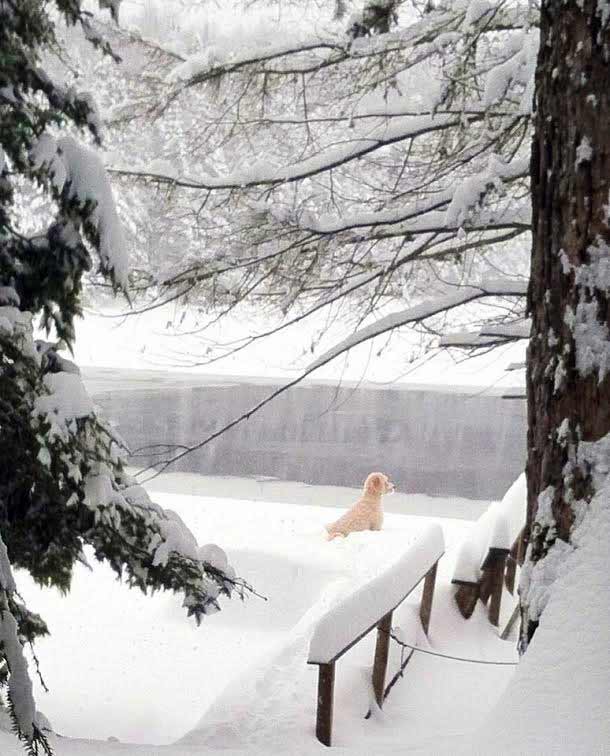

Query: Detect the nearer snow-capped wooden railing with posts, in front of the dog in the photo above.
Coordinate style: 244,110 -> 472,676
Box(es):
307,524 -> 445,746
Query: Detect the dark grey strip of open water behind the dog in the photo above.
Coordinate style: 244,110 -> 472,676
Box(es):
88,370 -> 526,499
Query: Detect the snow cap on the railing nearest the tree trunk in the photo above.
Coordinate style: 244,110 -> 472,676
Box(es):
453,473 -> 527,583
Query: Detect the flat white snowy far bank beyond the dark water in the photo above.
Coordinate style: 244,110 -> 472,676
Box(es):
65,296 -> 525,388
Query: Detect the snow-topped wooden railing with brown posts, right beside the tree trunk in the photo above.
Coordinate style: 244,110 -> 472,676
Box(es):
451,474 -> 527,625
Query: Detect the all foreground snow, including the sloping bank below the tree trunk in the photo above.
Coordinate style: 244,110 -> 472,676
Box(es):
0,476 -> 610,756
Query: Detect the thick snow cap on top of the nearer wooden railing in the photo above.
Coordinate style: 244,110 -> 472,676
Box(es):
308,523 -> 445,664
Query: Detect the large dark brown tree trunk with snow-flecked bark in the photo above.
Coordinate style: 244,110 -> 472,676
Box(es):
521,0 -> 610,650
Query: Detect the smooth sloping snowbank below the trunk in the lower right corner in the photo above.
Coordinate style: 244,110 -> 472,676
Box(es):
477,487 -> 610,756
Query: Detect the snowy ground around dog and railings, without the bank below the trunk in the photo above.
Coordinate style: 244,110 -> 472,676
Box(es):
0,476 -> 515,756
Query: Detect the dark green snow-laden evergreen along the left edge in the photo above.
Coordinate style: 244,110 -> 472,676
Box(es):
0,0 -> 247,753
